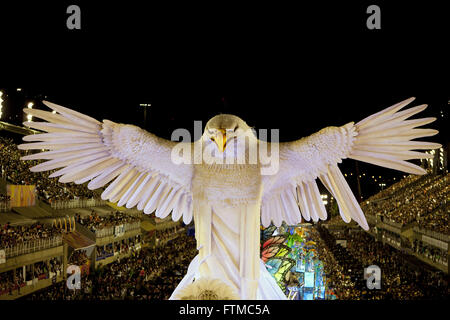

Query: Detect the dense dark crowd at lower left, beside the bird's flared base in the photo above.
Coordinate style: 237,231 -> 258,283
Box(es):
26,235 -> 197,300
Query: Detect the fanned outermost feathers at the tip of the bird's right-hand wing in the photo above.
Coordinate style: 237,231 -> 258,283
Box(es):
349,98 -> 441,175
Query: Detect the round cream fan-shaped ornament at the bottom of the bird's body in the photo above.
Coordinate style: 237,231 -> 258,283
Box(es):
174,277 -> 240,300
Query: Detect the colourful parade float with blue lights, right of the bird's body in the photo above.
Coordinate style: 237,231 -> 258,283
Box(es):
261,223 -> 336,300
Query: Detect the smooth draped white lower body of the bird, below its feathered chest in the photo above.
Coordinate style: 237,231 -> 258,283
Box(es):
171,204 -> 286,300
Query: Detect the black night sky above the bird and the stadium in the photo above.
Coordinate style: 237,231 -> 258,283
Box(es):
0,1 -> 450,196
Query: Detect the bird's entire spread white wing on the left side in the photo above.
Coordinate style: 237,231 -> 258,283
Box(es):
19,101 -> 193,223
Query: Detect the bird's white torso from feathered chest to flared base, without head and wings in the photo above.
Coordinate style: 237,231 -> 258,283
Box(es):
172,148 -> 286,300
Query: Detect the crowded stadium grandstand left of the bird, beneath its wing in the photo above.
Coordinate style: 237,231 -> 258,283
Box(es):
0,126 -> 190,300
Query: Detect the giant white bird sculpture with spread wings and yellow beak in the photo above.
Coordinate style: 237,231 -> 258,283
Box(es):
19,98 -> 440,299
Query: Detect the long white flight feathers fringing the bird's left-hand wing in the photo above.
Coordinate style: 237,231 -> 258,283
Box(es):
18,101 -> 192,224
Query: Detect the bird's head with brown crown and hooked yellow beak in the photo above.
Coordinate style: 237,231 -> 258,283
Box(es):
203,114 -> 251,153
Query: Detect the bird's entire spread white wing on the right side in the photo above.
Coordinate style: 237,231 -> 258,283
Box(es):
261,98 -> 441,230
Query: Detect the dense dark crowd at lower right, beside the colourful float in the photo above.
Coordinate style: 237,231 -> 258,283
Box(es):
318,226 -> 448,300
